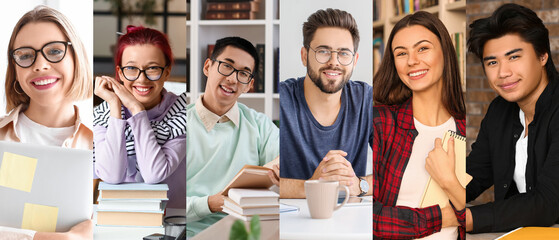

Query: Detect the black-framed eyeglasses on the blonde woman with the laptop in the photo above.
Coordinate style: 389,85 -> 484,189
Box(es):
10,41 -> 72,68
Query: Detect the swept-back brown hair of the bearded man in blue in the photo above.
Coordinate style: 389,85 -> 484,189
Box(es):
303,8 -> 359,53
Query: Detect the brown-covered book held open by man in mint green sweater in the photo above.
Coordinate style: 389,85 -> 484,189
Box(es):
222,165 -> 274,196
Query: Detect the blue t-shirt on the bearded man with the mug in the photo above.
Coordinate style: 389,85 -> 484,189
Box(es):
280,78 -> 373,179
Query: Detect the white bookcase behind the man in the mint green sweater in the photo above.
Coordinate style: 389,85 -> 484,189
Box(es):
186,0 -> 279,120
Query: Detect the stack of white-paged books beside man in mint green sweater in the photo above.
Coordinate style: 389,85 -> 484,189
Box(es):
223,188 -> 279,221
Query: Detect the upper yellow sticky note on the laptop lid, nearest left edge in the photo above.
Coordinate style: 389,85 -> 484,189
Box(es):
0,152 -> 37,192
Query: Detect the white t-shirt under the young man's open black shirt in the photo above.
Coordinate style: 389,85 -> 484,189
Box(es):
513,109 -> 528,193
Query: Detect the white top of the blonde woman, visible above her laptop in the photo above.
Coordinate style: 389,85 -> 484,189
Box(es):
15,112 -> 75,146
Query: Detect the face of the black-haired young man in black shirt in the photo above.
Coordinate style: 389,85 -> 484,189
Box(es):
483,34 -> 548,105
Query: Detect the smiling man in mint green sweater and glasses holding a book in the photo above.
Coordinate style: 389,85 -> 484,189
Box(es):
186,37 -> 279,236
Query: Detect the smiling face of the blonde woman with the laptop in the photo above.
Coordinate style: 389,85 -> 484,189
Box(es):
13,22 -> 74,106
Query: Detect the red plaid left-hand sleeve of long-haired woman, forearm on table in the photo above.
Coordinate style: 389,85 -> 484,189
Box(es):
373,107 -> 442,239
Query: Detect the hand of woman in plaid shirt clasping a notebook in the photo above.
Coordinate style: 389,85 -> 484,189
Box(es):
425,138 -> 459,189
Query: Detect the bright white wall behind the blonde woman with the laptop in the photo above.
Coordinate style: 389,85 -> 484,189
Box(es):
0,0 -> 93,127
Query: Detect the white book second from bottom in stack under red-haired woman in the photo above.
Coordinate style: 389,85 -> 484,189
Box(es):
97,199 -> 165,211
